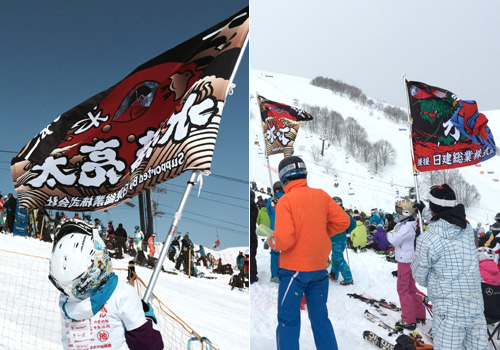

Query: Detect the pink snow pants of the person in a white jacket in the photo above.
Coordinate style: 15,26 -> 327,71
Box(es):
397,262 -> 426,323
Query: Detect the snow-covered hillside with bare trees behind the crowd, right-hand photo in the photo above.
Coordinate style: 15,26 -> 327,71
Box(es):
249,70 -> 500,225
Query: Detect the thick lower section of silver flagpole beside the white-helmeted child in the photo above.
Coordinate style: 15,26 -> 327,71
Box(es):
143,170 -> 200,303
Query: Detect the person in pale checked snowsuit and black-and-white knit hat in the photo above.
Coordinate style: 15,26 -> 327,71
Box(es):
411,184 -> 488,350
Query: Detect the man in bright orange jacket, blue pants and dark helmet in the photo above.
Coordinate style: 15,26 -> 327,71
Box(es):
269,156 -> 350,350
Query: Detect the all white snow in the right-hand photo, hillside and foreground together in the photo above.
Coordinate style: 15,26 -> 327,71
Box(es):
249,70 -> 500,350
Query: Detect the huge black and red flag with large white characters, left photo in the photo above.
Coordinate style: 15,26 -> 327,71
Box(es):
11,7 -> 249,212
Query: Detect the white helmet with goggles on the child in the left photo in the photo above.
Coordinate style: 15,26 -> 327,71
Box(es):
49,219 -> 112,299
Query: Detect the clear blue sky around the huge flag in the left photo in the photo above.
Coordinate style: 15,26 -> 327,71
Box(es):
0,0 -> 249,249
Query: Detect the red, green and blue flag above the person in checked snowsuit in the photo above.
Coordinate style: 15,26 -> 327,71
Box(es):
406,81 -> 496,172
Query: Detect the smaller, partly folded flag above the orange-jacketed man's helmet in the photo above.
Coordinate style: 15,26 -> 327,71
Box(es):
258,96 -> 313,157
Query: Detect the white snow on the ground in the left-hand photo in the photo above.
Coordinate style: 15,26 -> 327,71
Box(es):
0,234 -> 250,350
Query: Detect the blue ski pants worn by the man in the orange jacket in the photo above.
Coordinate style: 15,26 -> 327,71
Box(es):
276,269 -> 338,350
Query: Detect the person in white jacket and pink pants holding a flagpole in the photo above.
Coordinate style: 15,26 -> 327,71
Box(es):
387,210 -> 425,330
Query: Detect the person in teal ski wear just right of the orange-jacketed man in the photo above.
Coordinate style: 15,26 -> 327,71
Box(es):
330,197 -> 356,286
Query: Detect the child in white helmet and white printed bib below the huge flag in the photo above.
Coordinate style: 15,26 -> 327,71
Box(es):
49,219 -> 163,350
